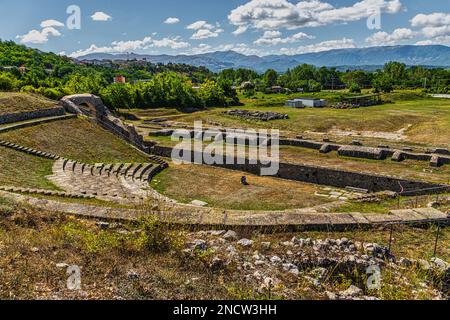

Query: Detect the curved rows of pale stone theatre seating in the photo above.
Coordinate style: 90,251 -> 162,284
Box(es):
48,159 -> 163,204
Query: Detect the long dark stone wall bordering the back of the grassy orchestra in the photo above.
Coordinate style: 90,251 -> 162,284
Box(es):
150,146 -> 450,195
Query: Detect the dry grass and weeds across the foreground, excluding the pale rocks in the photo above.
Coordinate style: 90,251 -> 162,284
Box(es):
0,199 -> 450,299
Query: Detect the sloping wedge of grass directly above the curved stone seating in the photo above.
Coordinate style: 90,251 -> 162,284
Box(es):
0,118 -> 148,163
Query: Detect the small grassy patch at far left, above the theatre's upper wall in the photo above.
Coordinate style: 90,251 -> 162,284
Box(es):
0,92 -> 58,115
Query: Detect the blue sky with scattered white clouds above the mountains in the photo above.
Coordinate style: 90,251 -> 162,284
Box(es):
0,0 -> 450,56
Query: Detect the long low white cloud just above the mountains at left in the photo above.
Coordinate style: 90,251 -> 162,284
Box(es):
69,37 -> 190,58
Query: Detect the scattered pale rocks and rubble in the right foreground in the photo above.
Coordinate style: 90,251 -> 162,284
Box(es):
183,231 -> 450,300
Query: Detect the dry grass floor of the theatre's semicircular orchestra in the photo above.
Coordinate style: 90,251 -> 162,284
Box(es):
152,161 -> 330,210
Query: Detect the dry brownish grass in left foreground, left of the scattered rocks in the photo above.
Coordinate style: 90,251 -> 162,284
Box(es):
0,205 -> 227,300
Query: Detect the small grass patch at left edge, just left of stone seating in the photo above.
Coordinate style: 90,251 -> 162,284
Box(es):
0,147 -> 58,190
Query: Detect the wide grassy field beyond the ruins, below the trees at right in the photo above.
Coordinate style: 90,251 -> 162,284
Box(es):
128,91 -> 450,147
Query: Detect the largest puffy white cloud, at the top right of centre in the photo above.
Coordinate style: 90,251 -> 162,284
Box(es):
228,0 -> 402,32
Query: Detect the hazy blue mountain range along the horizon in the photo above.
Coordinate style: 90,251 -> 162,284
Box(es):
78,45 -> 450,72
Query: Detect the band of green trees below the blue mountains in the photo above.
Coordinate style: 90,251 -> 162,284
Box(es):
0,41 -> 450,109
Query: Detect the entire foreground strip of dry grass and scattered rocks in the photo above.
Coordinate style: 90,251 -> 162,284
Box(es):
0,199 -> 450,300
